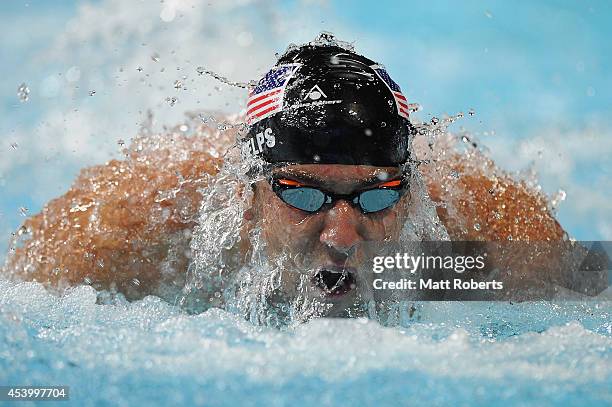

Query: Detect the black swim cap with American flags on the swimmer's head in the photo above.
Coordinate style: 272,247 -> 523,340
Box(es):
244,44 -> 413,167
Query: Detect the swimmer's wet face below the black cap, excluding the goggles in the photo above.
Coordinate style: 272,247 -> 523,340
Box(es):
250,164 -> 410,315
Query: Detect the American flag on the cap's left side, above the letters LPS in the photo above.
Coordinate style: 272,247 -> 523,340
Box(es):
247,64 -> 300,125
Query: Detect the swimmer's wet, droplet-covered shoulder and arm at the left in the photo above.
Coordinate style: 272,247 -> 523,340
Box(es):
3,152 -> 218,298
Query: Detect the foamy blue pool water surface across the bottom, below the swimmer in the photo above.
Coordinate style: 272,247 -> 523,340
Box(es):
0,280 -> 612,406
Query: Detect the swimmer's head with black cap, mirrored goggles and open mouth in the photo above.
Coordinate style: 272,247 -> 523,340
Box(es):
230,46 -> 415,315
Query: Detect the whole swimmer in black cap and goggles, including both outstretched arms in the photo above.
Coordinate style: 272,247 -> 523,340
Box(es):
4,39 -> 596,315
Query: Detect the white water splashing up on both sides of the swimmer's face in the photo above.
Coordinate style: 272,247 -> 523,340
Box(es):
175,107 -> 449,327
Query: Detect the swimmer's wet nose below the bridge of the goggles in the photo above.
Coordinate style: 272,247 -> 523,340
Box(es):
319,201 -> 363,254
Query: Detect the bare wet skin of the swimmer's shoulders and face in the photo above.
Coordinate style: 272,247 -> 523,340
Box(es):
0,129 -> 572,302
